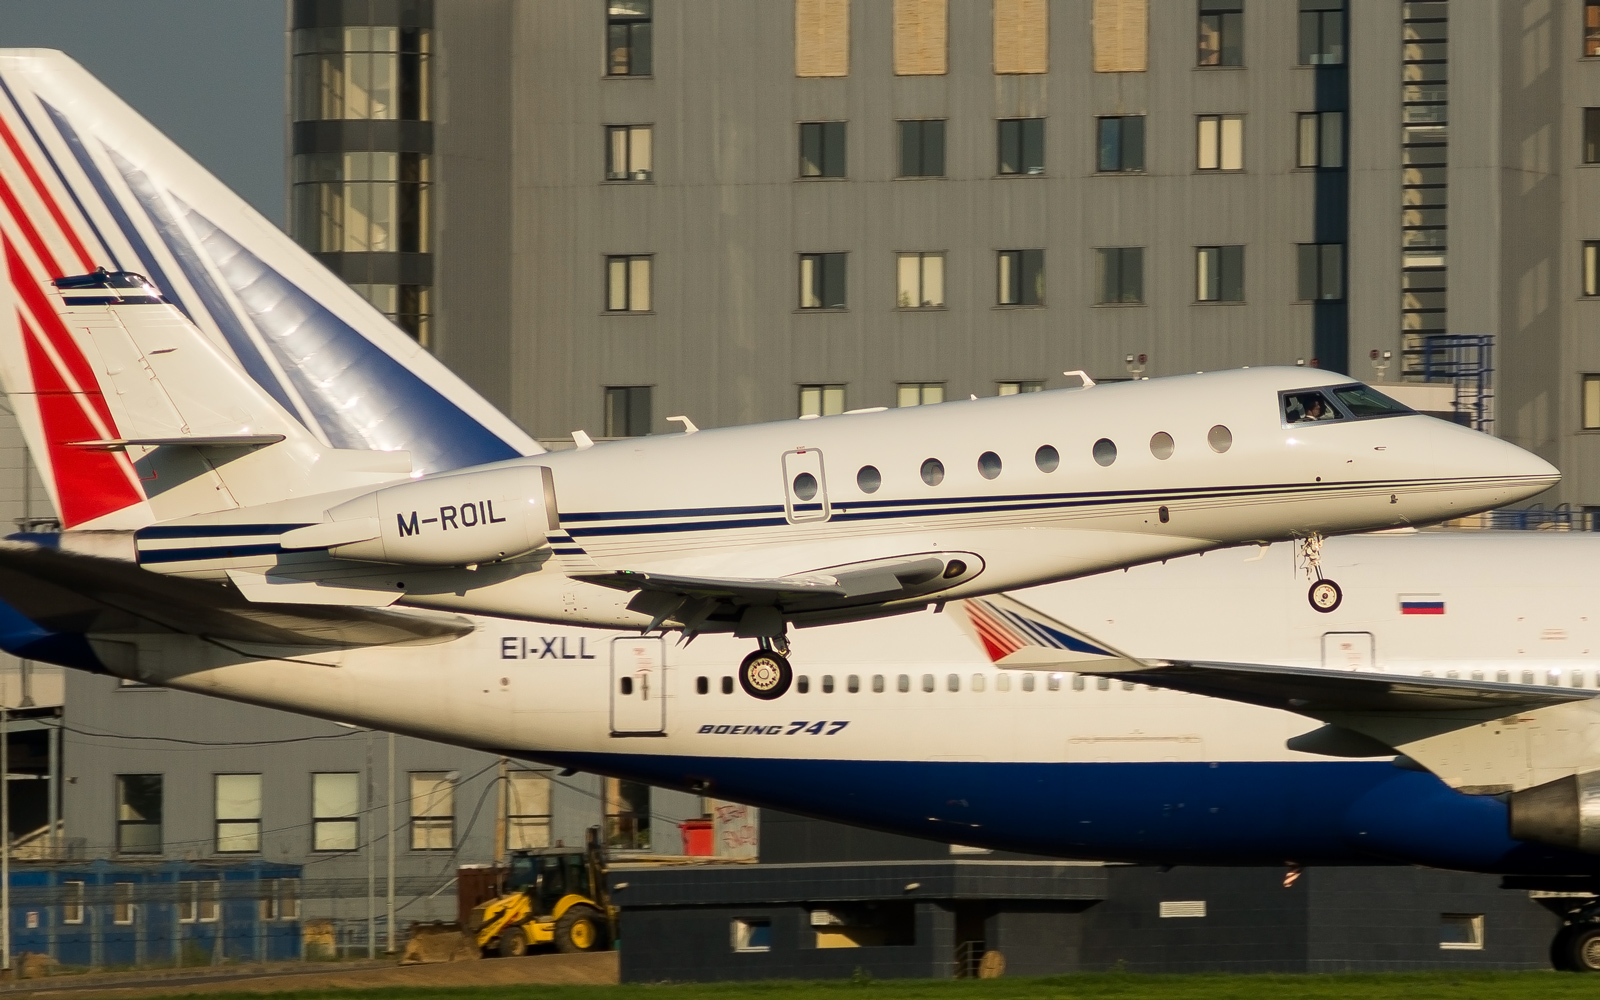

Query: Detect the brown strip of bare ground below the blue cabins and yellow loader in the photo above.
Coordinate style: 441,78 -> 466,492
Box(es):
0,952 -> 618,1000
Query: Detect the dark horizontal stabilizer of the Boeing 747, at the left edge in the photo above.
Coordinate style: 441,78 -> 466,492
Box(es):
0,541 -> 474,648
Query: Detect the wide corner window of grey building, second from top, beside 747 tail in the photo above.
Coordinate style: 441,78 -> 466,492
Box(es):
291,152 -> 434,253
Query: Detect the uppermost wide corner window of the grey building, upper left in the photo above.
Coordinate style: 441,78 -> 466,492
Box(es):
291,26 -> 432,122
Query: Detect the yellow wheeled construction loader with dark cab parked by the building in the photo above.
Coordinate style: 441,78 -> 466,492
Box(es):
466,829 -> 616,958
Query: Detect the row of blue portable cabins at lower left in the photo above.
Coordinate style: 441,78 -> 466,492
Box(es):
11,859 -> 301,968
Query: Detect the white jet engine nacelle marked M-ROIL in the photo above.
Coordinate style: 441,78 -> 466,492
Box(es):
328,466 -> 558,566
